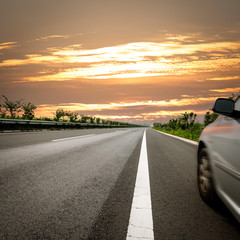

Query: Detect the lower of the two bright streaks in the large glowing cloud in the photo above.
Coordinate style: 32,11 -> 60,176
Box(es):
20,57 -> 240,82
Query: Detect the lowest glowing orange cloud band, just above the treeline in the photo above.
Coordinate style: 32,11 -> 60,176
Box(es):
33,97 -> 219,119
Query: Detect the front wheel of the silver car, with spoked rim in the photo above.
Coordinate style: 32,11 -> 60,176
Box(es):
197,148 -> 216,204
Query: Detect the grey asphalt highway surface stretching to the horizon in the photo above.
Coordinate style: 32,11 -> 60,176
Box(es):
0,128 -> 240,240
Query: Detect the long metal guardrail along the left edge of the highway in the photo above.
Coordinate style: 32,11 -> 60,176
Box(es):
0,118 -> 137,128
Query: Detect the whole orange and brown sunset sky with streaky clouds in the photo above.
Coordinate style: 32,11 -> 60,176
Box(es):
0,0 -> 240,123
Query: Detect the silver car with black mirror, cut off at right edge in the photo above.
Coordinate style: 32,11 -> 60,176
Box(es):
197,94 -> 240,222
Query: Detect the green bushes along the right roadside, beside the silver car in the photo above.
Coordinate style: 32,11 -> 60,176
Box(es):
153,111 -> 218,141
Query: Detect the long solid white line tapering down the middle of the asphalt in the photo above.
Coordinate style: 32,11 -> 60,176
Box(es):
126,130 -> 154,240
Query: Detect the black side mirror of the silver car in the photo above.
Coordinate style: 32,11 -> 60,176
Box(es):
212,98 -> 235,117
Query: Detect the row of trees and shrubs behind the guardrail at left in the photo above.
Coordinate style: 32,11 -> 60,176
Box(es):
0,95 -> 133,126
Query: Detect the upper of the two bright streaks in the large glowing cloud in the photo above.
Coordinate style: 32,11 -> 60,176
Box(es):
50,40 -> 240,58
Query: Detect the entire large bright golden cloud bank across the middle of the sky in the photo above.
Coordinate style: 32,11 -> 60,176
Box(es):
0,35 -> 240,82
